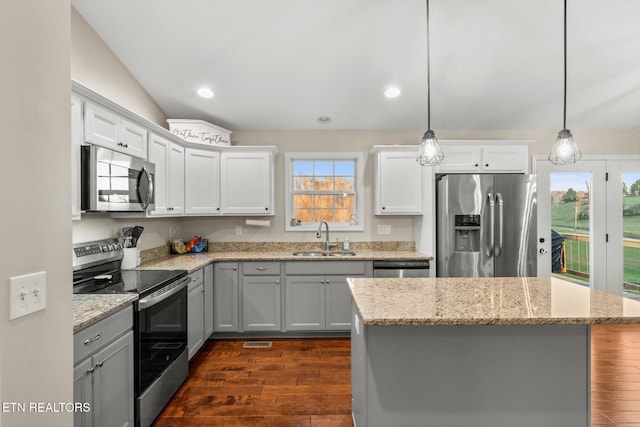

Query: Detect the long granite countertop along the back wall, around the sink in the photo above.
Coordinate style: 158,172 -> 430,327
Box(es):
137,250 -> 433,273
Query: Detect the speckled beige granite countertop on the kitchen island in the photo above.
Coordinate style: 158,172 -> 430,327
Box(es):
348,277 -> 640,326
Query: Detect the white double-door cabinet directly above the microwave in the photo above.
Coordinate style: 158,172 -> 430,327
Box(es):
84,102 -> 147,159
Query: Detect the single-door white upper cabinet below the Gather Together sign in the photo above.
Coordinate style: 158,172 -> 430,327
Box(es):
184,148 -> 221,215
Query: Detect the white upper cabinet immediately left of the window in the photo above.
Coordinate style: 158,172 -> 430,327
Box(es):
220,151 -> 273,215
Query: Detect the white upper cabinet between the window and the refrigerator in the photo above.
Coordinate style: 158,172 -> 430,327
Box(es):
371,146 -> 425,215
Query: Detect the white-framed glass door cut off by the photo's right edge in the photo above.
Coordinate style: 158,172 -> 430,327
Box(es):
607,160 -> 640,299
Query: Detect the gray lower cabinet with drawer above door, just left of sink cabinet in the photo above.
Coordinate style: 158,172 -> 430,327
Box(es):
242,262 -> 282,331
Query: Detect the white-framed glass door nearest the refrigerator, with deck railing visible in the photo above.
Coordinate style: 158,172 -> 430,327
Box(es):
535,159 -> 607,290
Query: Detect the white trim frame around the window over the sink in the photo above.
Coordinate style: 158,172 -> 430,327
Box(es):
284,152 -> 364,231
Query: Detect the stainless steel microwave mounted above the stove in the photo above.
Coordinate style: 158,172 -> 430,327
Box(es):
81,145 -> 156,212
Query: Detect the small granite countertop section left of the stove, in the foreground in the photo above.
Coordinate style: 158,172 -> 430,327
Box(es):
73,294 -> 138,332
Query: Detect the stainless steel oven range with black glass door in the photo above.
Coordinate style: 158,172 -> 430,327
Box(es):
73,239 -> 191,427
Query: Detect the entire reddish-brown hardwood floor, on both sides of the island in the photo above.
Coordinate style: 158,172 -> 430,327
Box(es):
154,325 -> 640,427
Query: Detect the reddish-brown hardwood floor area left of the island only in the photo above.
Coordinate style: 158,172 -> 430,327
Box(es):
154,339 -> 353,427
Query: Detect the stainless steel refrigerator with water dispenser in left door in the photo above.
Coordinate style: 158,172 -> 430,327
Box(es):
436,174 -> 537,277
